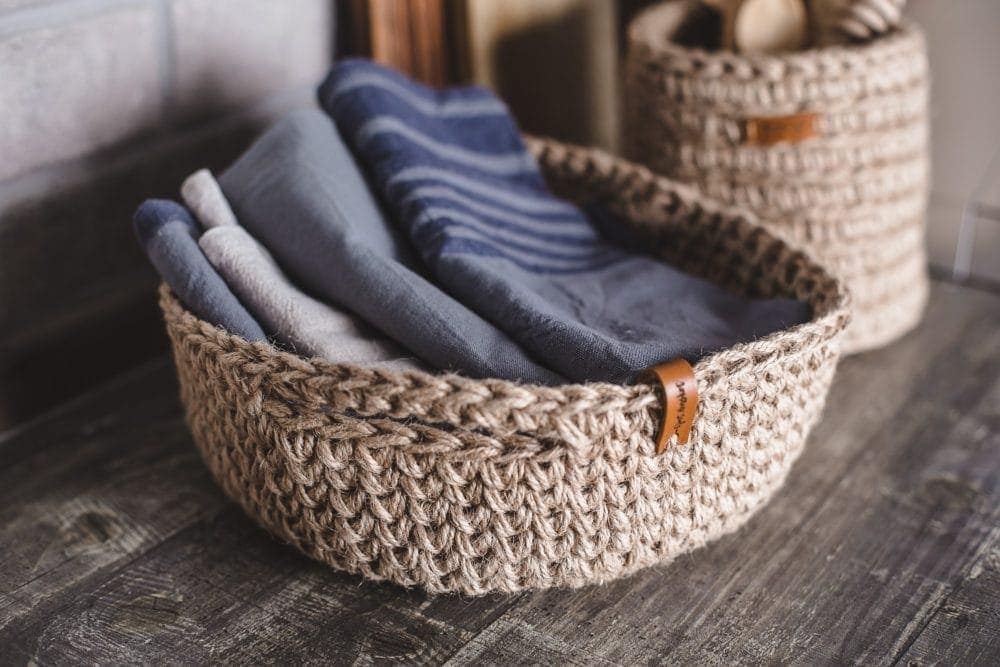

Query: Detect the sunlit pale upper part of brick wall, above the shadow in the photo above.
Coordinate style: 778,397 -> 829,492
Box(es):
0,0 -> 333,181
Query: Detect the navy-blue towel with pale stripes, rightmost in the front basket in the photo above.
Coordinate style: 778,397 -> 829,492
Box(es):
319,60 -> 809,382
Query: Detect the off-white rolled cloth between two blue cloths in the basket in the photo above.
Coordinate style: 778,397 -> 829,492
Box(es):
181,169 -> 421,370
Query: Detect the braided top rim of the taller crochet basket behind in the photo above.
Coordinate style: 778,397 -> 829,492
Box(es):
627,0 -> 923,71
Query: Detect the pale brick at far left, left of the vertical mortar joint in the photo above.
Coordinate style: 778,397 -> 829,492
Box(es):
0,5 -> 162,179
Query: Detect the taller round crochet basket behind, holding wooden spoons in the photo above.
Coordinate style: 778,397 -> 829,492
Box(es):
624,0 -> 929,352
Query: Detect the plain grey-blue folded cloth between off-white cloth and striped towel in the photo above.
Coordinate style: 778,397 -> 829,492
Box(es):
219,110 -> 563,384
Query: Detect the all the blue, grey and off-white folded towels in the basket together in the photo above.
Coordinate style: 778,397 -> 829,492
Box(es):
135,60 -> 810,385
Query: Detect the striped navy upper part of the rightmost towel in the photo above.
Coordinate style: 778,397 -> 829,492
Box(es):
323,61 -> 626,273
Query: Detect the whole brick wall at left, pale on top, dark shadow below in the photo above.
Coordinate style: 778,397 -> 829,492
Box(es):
0,0 -> 335,428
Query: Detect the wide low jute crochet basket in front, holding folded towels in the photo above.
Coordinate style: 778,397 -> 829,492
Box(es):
160,140 -> 849,595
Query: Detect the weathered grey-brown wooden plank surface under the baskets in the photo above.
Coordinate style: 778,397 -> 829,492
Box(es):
0,283 -> 1000,665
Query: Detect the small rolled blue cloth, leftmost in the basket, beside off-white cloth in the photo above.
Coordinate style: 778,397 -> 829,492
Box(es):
132,199 -> 266,341
